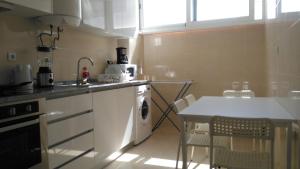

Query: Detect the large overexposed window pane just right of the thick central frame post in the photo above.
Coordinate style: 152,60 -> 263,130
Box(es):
197,0 -> 249,21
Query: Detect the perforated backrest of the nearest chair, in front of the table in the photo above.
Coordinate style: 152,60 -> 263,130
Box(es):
210,116 -> 274,140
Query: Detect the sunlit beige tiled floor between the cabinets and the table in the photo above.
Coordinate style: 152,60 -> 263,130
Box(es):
105,125 -> 209,169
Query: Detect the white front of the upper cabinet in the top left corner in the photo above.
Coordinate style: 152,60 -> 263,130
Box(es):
0,0 -> 52,13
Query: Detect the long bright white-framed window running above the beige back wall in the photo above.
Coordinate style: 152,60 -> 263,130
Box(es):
140,0 -> 278,33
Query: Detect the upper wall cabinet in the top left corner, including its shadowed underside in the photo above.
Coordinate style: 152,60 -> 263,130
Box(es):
0,0 -> 52,17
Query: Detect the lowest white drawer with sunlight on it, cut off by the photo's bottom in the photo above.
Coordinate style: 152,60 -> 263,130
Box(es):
61,151 -> 94,169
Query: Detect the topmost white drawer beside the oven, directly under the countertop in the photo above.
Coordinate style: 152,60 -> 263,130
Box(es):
45,94 -> 92,121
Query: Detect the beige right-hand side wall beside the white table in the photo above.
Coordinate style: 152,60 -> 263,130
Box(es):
266,13 -> 300,168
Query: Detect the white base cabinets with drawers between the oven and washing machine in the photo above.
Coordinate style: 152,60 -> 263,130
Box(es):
40,87 -> 136,169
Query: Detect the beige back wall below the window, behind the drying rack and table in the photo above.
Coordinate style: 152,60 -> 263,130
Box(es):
144,25 -> 267,125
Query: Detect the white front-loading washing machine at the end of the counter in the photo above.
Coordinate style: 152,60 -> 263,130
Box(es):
134,85 -> 152,145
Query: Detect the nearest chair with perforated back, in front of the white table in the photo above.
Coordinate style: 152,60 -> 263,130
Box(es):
209,116 -> 274,169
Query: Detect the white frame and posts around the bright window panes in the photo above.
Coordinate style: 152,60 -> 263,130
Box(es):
139,0 -> 300,34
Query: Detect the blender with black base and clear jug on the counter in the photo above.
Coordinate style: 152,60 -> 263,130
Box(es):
37,46 -> 54,88
